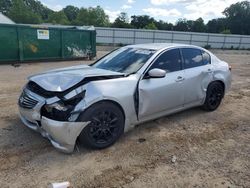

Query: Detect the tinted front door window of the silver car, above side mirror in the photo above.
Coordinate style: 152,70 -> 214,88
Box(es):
150,49 -> 181,72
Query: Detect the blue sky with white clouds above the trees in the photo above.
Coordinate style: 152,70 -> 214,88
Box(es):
40,0 -> 244,23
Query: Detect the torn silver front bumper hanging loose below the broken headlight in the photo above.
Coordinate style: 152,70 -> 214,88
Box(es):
19,91 -> 89,153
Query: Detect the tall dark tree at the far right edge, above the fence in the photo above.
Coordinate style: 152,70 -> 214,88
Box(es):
223,1 -> 250,35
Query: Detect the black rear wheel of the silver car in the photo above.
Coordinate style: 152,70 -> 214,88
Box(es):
202,82 -> 224,111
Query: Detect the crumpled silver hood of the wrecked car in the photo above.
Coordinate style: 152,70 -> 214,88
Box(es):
29,65 -> 123,92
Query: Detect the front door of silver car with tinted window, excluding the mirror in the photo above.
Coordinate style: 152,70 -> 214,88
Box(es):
138,49 -> 184,120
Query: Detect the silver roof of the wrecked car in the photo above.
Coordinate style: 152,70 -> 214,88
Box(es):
126,43 -> 200,51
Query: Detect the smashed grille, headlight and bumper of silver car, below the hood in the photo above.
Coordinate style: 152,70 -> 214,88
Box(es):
19,81 -> 88,153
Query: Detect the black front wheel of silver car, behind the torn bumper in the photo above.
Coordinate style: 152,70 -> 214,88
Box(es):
78,101 -> 125,149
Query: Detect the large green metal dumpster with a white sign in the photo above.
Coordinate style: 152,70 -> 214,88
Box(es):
0,24 -> 96,62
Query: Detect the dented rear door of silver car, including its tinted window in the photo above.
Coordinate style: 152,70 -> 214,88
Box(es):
181,48 -> 213,105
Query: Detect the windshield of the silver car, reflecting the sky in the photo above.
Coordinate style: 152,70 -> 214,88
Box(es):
92,47 -> 155,74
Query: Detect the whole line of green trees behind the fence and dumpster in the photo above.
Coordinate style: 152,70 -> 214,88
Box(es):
0,0 -> 250,35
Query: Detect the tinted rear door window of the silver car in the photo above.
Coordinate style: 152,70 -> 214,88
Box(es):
182,48 -> 204,69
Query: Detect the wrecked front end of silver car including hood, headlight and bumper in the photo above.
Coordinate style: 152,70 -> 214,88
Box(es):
19,65 -> 127,153
